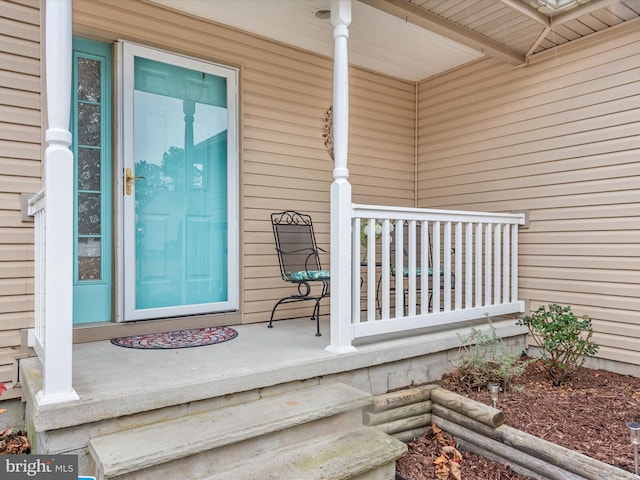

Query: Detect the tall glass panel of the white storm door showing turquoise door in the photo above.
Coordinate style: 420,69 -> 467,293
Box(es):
131,56 -> 228,313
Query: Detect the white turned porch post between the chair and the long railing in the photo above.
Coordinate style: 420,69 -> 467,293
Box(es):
326,0 -> 355,353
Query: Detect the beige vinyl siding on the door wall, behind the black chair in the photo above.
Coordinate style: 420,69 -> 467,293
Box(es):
73,0 -> 415,322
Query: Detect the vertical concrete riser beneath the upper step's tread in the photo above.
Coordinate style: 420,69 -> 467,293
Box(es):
106,409 -> 360,480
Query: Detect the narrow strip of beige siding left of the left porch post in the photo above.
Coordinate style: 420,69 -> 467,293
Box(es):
0,0 -> 42,400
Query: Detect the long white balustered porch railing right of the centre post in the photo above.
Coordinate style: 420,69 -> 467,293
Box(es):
351,204 -> 524,339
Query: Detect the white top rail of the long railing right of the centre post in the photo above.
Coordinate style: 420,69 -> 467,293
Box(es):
351,203 -> 525,225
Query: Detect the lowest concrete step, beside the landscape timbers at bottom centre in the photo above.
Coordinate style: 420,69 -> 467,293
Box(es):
198,427 -> 407,480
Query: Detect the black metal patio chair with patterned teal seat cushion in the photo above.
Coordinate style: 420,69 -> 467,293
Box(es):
268,210 -> 331,336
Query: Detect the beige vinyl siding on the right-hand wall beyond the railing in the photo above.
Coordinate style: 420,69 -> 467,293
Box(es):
418,21 -> 640,364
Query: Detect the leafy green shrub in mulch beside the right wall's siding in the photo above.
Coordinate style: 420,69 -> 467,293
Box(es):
518,304 -> 599,386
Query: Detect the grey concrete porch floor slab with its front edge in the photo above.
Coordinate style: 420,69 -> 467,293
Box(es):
20,317 -> 526,431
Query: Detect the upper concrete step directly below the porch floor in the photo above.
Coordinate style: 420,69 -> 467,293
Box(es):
89,383 -> 372,480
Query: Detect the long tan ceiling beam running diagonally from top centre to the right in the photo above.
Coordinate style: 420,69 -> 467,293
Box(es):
360,0 -> 525,65
